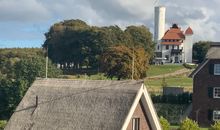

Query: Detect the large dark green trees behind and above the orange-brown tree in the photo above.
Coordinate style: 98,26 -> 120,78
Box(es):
43,20 -> 154,69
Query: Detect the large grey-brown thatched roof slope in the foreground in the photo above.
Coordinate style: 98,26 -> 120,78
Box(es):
5,79 -> 150,130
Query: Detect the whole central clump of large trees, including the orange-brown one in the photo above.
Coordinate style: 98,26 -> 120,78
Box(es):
43,20 -> 154,79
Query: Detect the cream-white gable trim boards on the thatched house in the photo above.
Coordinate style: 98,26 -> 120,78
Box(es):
121,84 -> 162,130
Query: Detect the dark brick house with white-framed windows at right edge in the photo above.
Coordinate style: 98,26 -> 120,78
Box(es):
190,43 -> 220,126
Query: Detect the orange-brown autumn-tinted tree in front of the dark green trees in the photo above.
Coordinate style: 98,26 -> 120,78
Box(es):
101,46 -> 148,80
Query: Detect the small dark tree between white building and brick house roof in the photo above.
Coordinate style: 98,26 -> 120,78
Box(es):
193,41 -> 211,63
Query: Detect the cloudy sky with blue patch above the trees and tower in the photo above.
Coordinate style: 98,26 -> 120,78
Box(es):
0,0 -> 220,48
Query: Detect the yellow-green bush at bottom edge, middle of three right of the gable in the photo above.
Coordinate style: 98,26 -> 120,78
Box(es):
179,118 -> 199,130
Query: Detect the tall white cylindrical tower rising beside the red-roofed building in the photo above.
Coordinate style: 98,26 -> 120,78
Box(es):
154,6 -> 166,52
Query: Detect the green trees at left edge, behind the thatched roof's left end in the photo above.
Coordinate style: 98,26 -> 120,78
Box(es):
0,48 -> 62,120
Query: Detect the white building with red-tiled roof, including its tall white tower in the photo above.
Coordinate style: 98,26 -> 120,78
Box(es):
154,6 -> 193,63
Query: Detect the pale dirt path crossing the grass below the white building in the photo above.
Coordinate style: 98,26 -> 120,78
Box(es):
147,68 -> 193,79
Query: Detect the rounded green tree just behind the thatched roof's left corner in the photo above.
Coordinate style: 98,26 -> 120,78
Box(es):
14,57 -> 61,93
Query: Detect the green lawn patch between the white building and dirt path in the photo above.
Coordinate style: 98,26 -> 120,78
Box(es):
147,64 -> 184,76
